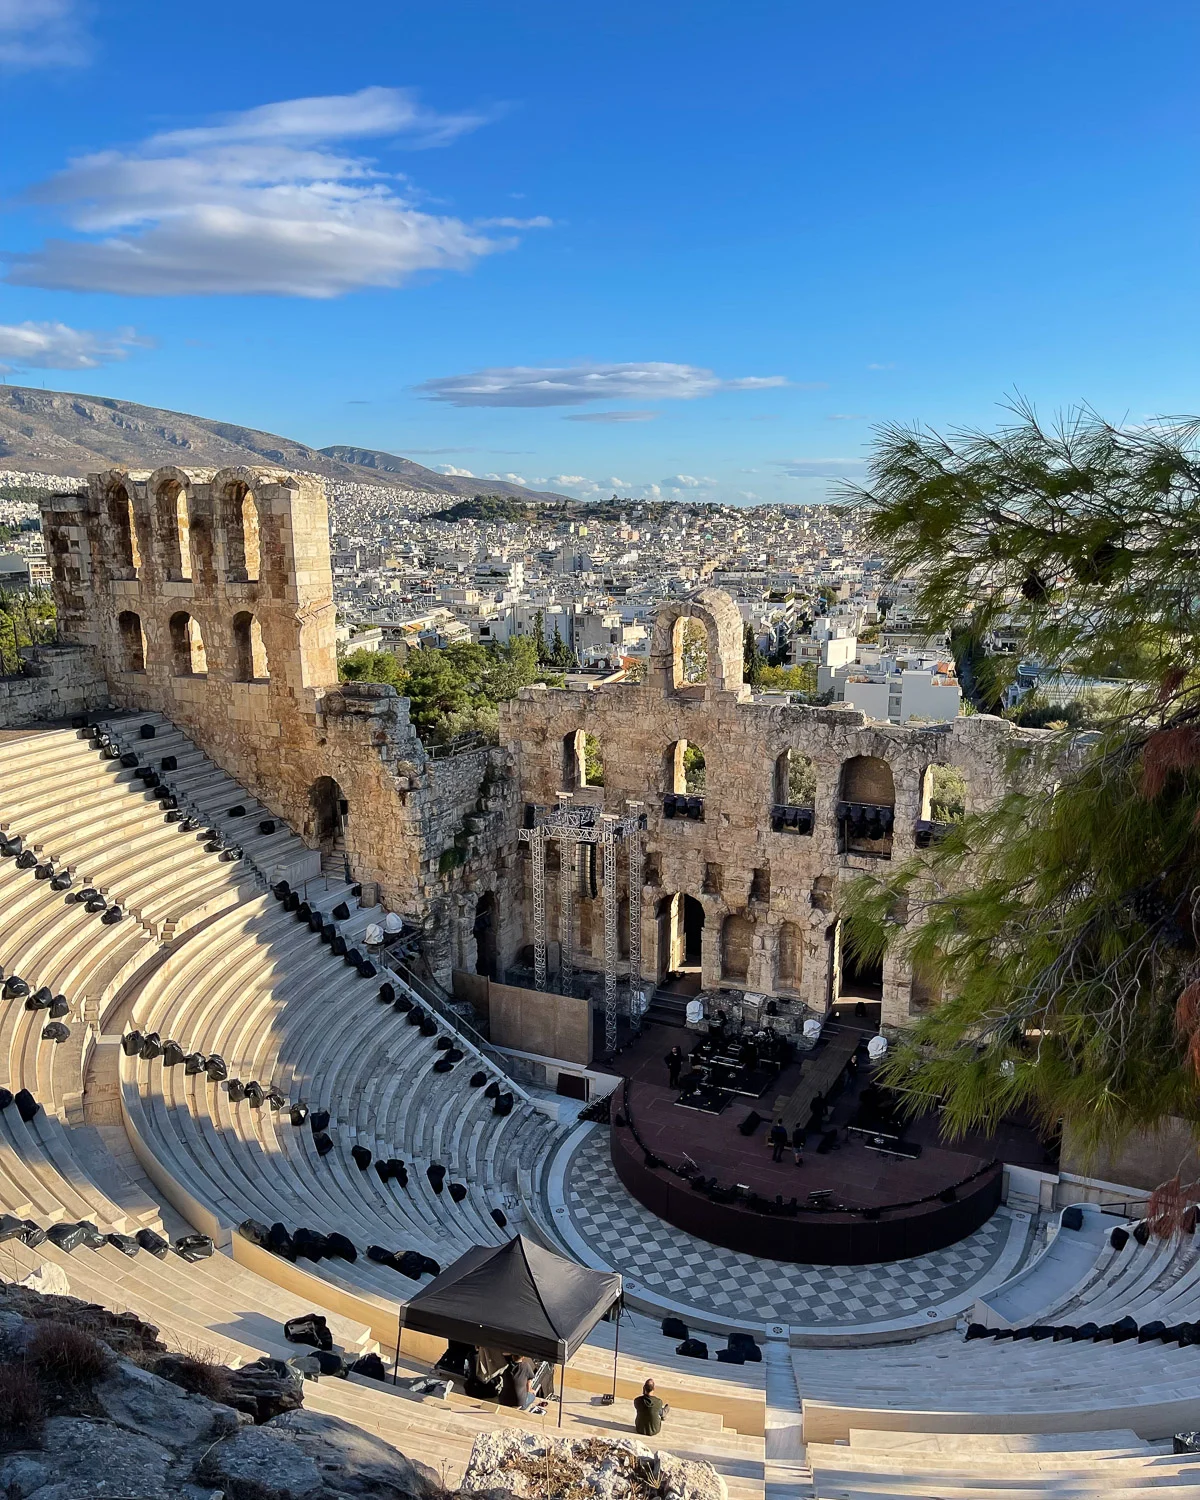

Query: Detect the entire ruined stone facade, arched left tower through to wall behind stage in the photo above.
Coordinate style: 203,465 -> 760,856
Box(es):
30,468 -> 1040,1025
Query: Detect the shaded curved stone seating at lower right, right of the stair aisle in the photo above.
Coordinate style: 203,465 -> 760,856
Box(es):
792,1206 -> 1200,1446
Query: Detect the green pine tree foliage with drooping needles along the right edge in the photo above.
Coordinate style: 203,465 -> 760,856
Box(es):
845,407 -> 1200,1146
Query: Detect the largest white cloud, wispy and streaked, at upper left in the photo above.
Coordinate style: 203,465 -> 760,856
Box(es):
9,85 -> 515,297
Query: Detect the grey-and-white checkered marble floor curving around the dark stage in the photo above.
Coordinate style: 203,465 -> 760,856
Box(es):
566,1130 -> 1008,1326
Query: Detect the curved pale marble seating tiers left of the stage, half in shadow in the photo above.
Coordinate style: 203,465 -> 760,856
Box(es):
0,716 -> 764,1500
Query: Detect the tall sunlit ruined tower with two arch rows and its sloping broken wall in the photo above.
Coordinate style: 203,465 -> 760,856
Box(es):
35,468 -> 512,978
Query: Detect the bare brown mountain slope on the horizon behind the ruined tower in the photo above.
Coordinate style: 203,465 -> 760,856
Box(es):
0,386 -> 573,501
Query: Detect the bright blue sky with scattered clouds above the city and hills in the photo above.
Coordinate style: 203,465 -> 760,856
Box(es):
0,0 -> 1200,501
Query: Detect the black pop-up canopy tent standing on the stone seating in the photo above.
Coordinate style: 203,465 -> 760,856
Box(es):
396,1235 -> 621,1425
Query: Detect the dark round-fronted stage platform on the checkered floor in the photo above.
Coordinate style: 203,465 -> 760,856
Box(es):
609,1026 -> 1041,1266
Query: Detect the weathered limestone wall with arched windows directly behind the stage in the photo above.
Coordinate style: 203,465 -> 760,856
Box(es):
501,591 -> 1041,1026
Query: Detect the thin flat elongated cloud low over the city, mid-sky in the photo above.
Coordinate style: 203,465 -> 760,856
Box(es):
417,362 -> 788,407
